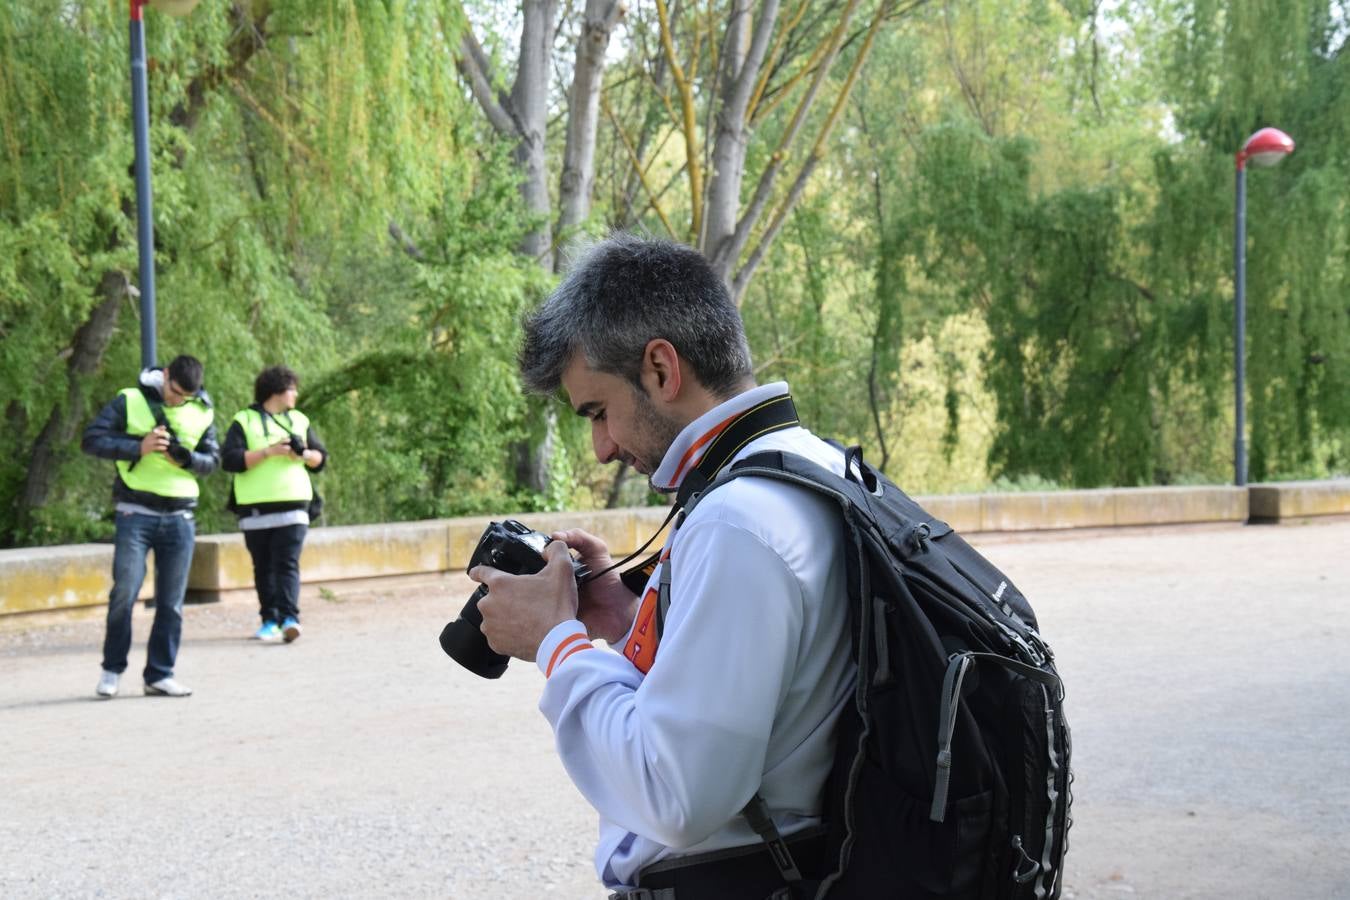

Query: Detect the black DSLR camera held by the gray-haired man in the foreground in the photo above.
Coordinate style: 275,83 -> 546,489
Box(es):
440,519 -> 590,679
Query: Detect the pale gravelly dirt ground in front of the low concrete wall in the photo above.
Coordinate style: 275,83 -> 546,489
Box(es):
0,519 -> 1350,900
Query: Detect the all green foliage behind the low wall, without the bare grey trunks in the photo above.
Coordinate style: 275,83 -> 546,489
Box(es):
0,0 -> 1350,545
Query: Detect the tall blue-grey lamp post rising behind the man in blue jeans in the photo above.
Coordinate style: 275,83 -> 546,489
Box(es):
131,0 -> 197,368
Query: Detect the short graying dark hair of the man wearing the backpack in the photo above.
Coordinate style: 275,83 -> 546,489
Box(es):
518,233 -> 753,398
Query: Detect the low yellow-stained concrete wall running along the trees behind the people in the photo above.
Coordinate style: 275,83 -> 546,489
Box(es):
0,479 -> 1350,615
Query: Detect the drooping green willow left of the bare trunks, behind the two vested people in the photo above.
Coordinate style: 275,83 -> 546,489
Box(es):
0,0 -> 535,542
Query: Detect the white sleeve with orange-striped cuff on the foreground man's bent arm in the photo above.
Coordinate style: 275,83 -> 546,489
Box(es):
539,519 -> 802,849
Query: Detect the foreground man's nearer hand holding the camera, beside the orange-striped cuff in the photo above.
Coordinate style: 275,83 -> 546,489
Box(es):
468,541 -> 576,663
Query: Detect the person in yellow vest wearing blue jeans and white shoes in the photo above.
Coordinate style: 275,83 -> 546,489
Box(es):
80,356 -> 220,699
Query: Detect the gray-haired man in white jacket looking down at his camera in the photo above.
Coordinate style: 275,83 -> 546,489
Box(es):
470,235 -> 856,900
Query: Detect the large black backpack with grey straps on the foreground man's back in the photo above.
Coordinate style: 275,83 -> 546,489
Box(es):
680,448 -> 1072,900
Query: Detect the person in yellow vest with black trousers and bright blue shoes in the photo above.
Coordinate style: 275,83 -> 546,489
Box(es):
221,366 -> 328,644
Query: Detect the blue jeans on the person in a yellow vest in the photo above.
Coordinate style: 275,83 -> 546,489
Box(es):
103,513 -> 196,684
